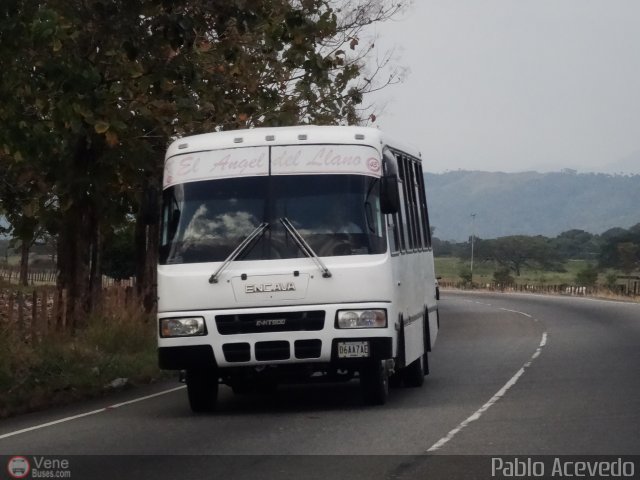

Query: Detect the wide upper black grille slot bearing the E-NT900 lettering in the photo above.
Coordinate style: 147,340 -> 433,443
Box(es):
216,310 -> 325,335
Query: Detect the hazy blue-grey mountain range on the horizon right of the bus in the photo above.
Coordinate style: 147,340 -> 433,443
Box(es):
425,170 -> 640,241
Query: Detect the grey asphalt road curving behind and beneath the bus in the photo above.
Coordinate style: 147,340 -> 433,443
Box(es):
0,292 -> 640,478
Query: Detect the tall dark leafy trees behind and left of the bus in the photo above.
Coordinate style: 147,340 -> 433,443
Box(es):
0,0 -> 401,325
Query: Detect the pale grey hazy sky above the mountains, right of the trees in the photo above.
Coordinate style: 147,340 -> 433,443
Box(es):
369,0 -> 640,173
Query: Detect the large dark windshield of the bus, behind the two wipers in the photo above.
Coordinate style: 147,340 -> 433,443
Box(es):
160,174 -> 387,265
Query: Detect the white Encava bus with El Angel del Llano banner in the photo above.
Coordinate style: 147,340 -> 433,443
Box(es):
158,126 -> 439,411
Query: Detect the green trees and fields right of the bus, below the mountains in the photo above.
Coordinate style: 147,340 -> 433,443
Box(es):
434,223 -> 640,286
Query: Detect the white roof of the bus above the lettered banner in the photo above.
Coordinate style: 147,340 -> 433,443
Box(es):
166,125 -> 420,158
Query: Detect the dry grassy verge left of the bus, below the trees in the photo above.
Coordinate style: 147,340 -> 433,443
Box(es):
0,314 -> 163,418
